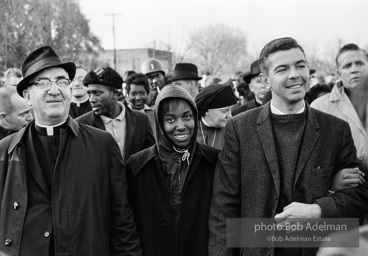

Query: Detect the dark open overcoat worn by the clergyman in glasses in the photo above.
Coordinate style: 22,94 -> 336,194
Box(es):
0,118 -> 141,256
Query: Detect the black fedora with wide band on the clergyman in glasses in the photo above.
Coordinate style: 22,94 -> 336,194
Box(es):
17,46 -> 76,97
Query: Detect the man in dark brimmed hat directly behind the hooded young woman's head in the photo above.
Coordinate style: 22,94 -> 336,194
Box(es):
171,63 -> 202,99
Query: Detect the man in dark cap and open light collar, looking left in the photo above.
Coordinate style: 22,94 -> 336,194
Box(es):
76,67 -> 155,162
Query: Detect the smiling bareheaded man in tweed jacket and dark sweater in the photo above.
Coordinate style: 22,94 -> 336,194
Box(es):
209,38 -> 368,256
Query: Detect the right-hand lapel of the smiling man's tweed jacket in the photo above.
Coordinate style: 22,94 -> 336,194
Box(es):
294,104 -> 319,188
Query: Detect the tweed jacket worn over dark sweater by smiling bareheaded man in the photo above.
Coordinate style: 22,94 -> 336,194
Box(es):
209,103 -> 368,256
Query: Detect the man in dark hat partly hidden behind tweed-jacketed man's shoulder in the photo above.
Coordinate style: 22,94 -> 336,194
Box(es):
232,60 -> 270,116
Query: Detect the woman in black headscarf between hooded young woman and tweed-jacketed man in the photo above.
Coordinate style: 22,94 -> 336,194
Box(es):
195,84 -> 236,149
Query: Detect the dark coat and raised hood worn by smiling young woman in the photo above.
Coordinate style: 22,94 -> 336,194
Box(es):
126,85 -> 219,256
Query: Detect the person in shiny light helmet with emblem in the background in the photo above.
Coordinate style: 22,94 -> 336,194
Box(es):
141,58 -> 166,107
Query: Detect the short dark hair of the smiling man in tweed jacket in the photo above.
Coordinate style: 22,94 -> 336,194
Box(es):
259,37 -> 305,74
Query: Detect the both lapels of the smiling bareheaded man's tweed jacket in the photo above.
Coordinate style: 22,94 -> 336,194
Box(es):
257,102 -> 320,194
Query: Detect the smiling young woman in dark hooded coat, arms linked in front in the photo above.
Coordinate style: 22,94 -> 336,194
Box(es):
126,85 -> 219,256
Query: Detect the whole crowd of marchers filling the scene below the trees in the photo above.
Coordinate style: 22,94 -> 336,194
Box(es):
0,37 -> 368,256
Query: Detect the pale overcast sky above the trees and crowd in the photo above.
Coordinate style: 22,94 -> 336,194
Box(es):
80,0 -> 368,59
